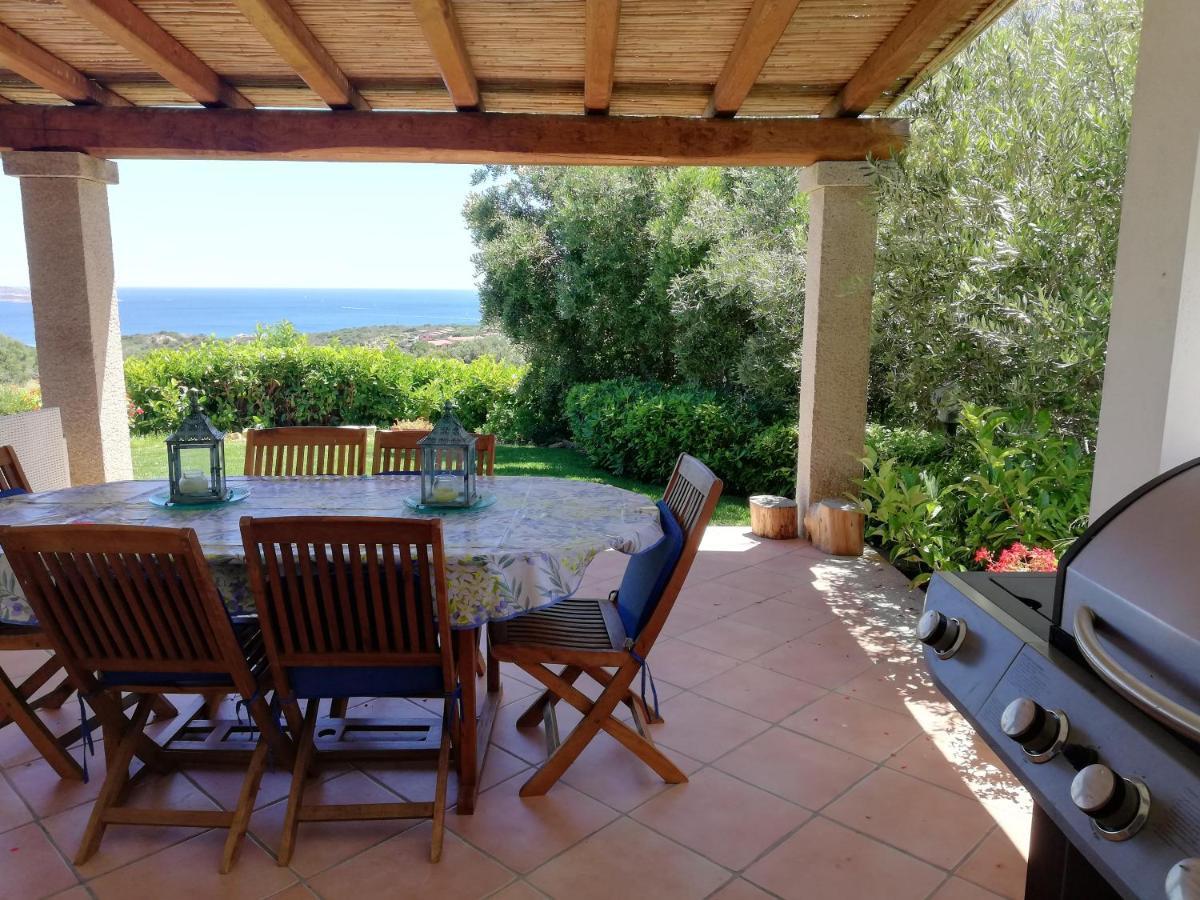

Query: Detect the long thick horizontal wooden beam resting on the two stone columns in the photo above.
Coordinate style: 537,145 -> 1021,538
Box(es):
0,104 -> 908,166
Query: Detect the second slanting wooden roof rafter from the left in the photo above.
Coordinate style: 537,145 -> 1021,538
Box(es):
60,0 -> 253,109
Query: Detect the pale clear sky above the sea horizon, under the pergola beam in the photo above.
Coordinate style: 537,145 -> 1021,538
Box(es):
0,160 -> 474,289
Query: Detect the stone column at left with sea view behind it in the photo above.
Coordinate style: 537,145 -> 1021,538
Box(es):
4,151 -> 133,485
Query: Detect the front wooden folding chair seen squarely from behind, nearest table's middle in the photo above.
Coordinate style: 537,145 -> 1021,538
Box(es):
241,516 -> 458,865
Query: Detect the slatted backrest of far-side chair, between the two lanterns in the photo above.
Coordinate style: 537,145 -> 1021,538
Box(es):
245,425 -> 367,476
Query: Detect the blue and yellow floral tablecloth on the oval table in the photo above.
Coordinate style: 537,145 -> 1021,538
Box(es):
0,475 -> 662,628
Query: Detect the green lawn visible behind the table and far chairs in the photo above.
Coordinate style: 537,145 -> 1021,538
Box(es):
131,434 -> 750,524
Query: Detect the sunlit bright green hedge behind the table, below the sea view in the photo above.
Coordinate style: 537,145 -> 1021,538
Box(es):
125,341 -> 523,434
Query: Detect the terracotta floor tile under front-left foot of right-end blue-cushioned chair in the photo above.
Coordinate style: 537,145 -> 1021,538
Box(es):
446,778 -> 618,872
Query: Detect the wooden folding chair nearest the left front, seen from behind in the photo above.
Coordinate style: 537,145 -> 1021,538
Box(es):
0,524 -> 293,872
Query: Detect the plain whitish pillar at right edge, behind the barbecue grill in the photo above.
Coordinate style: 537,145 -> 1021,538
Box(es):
1091,0 -> 1200,518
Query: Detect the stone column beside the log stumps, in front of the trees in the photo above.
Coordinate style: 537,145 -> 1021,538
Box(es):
796,162 -> 876,528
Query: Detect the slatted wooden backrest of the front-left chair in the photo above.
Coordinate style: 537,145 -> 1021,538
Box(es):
0,524 -> 254,692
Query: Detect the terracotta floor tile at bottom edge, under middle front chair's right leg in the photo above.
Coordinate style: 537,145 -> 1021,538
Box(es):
308,822 -> 512,900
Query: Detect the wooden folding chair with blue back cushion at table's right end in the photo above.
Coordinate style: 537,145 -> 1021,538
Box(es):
488,454 -> 722,797
